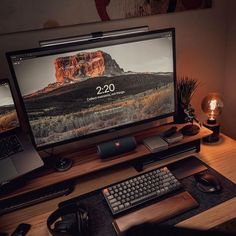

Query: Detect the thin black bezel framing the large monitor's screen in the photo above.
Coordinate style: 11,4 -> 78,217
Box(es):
6,28 -> 177,150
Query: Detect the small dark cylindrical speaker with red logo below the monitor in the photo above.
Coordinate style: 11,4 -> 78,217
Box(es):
97,136 -> 137,158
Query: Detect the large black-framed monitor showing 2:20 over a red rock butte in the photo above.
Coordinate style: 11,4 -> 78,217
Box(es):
7,29 -> 175,148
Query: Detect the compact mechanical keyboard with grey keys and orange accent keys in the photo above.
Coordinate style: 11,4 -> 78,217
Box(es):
102,167 -> 181,216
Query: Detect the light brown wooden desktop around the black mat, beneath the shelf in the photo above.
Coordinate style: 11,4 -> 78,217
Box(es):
0,135 -> 236,236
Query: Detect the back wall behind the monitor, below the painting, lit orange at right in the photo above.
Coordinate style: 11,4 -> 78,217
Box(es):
0,0 -> 227,136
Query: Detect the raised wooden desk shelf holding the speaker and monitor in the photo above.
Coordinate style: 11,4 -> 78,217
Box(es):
0,125 -> 211,200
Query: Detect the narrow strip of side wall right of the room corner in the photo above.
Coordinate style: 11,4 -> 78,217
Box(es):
222,0 -> 236,139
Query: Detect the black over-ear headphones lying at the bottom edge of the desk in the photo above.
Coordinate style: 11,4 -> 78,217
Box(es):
47,204 -> 89,236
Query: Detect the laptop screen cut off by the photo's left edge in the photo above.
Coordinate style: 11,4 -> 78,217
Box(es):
0,80 -> 20,134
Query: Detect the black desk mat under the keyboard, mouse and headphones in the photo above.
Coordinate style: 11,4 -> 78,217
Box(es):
59,156 -> 236,236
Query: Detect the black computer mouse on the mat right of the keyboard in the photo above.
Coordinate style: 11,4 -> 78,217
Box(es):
194,173 -> 222,193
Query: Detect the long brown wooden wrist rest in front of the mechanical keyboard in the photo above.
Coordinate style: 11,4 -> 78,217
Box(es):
113,191 -> 198,234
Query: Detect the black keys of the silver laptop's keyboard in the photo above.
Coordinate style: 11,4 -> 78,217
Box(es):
0,135 -> 23,160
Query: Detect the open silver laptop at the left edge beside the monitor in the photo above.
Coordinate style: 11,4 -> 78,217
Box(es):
0,79 -> 44,187
